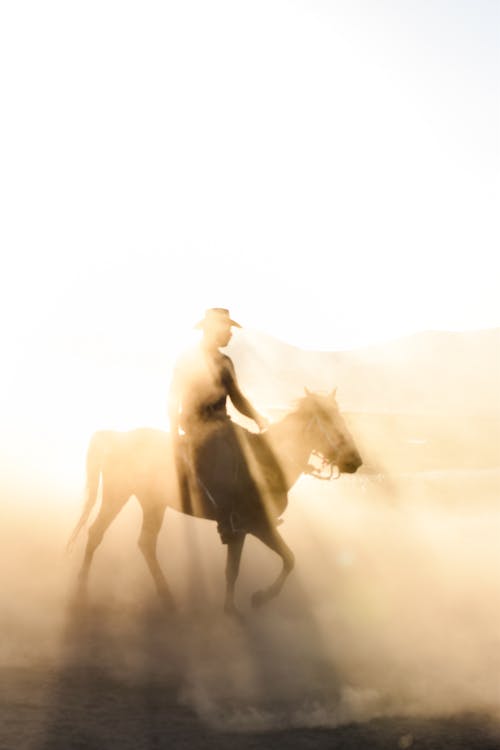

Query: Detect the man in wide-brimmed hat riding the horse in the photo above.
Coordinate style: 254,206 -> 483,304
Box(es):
169,307 -> 267,543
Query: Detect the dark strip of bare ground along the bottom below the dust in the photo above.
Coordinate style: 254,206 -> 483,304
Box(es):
0,666 -> 500,750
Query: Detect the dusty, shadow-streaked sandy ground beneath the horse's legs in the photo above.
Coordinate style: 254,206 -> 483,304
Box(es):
0,470 -> 500,750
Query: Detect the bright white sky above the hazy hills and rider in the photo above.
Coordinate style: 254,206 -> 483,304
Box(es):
0,0 -> 500,456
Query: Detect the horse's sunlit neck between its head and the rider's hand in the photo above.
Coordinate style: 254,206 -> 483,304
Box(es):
266,412 -> 311,487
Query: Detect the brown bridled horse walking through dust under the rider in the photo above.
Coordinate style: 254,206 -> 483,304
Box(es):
68,389 -> 362,615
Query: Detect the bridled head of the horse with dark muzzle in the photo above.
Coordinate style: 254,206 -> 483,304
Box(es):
300,388 -> 362,474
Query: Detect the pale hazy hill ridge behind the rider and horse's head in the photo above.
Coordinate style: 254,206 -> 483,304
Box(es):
228,328 -> 500,417
